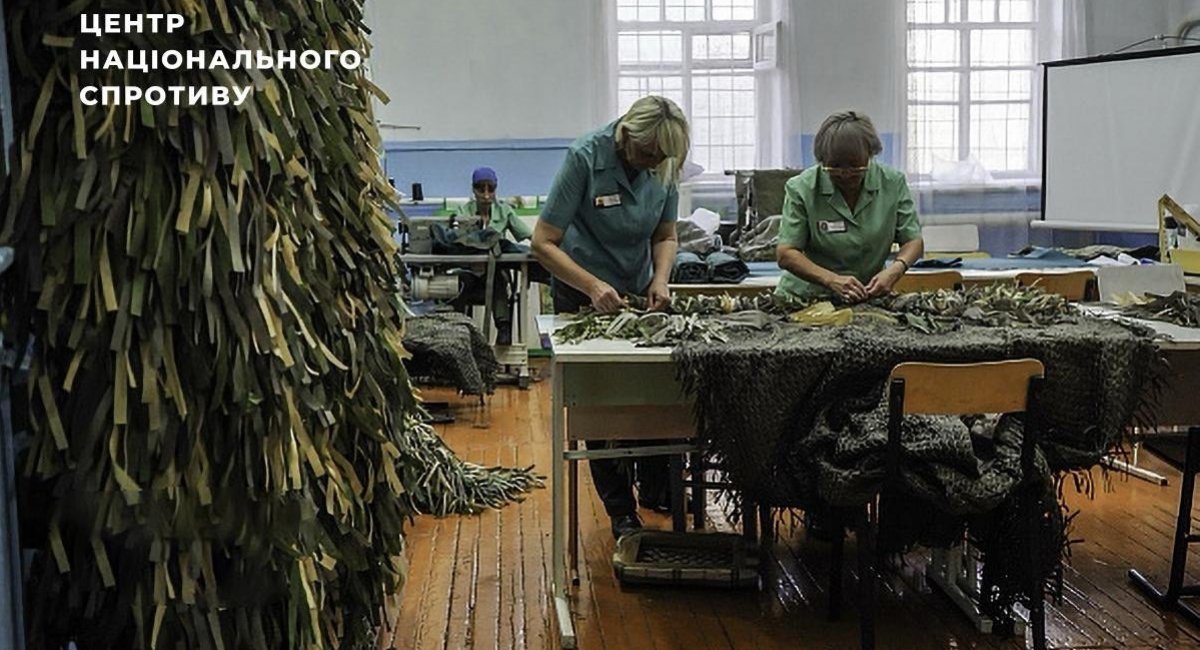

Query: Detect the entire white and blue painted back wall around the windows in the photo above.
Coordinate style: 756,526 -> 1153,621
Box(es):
367,0 -> 1200,252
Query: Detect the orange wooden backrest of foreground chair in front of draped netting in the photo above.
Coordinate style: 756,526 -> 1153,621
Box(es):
889,359 -> 1045,415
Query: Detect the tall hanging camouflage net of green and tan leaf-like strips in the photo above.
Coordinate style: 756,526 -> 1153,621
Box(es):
0,0 -> 539,650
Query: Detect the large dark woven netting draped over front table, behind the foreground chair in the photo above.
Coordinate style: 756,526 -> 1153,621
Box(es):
673,319 -> 1159,619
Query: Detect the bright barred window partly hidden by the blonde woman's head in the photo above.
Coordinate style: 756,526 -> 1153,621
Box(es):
614,0 -> 756,174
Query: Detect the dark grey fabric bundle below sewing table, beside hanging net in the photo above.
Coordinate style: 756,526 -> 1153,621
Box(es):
404,312 -> 499,395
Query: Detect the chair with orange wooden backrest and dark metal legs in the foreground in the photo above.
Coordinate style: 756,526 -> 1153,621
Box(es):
854,359 -> 1048,649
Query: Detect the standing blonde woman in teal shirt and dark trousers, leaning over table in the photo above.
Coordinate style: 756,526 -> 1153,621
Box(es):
533,96 -> 690,537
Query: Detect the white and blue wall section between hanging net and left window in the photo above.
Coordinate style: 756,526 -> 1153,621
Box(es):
367,0 -> 602,197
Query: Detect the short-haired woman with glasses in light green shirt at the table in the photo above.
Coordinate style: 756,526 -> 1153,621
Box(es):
775,110 -> 924,303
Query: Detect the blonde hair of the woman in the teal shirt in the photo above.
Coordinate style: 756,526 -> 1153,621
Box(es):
617,95 -> 691,185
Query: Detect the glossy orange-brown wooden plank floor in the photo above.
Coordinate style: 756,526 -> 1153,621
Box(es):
382,369 -> 1200,650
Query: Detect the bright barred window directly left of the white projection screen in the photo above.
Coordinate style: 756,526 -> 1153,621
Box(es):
906,0 -> 1037,177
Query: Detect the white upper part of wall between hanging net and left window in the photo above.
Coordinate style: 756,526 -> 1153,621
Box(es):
367,0 -> 602,140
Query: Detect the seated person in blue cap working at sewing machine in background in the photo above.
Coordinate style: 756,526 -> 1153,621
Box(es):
454,167 -> 533,345
